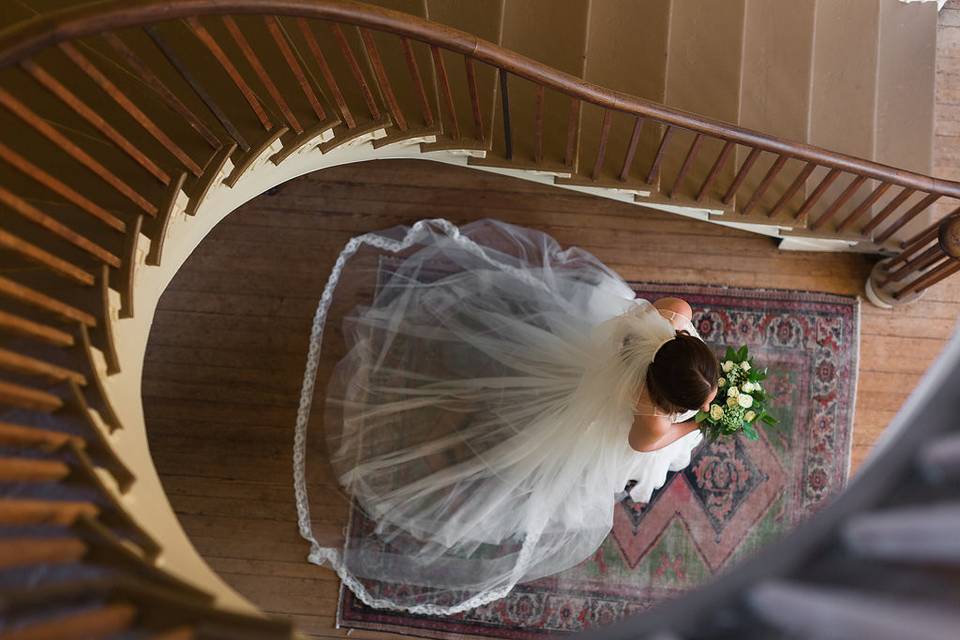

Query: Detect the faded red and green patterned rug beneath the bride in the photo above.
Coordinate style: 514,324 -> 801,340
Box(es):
338,284 -> 859,639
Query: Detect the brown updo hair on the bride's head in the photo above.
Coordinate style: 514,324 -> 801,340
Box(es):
646,331 -> 720,413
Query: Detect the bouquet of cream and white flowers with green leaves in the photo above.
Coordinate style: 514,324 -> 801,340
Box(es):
695,346 -> 779,442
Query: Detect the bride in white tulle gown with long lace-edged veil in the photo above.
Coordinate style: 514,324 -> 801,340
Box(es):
294,220 -> 719,615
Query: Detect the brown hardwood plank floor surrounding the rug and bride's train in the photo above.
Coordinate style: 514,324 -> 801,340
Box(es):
143,3 -> 960,637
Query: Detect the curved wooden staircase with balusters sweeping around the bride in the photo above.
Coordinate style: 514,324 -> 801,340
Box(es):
0,0 -> 960,640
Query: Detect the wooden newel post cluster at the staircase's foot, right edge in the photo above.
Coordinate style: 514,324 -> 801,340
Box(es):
866,215 -> 960,309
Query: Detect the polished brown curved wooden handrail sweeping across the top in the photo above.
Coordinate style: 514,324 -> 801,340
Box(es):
0,0 -> 960,198
